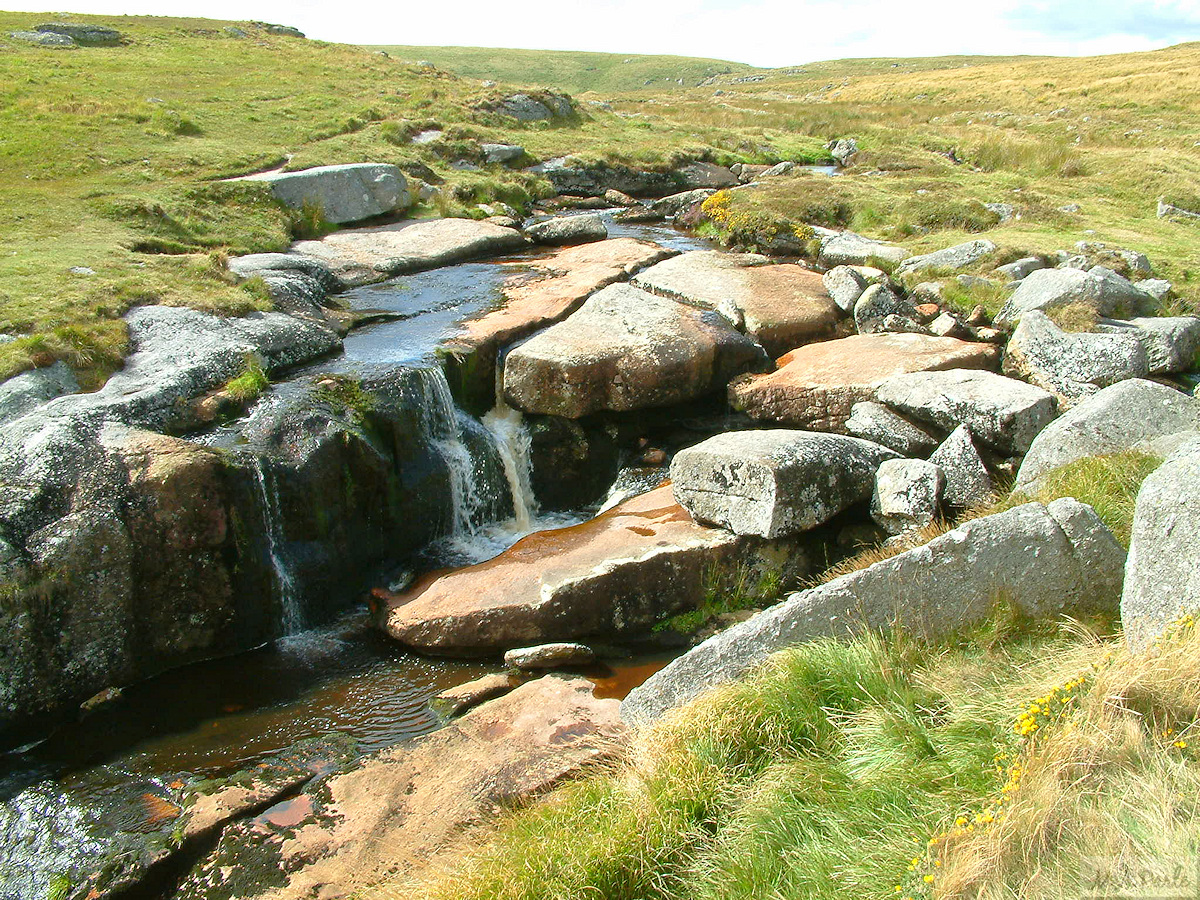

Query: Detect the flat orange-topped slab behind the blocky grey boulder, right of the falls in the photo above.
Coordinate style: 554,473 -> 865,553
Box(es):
730,334 -> 1000,431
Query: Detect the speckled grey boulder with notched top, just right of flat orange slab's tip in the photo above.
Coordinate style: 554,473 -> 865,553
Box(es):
1003,310 -> 1150,403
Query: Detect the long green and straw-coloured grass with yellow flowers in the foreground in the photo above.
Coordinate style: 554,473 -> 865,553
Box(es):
367,454 -> 1200,900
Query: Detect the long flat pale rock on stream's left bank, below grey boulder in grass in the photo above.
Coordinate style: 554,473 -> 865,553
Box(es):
292,218 -> 526,286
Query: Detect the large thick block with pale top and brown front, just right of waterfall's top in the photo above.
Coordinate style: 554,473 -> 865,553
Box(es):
504,284 -> 767,419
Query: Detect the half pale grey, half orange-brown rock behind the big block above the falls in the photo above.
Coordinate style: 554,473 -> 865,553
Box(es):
634,250 -> 841,356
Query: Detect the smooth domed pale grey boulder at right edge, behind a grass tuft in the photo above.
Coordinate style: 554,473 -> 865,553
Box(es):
1016,378 -> 1200,491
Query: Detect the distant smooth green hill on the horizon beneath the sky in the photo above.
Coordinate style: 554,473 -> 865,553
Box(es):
371,44 -> 764,94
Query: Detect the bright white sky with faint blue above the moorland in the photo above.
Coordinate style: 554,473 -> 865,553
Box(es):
0,0 -> 1200,66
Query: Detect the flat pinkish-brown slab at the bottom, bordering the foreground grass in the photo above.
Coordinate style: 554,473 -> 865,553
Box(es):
176,676 -> 625,900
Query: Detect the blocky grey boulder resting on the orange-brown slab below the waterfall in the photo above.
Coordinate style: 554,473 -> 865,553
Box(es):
671,428 -> 896,538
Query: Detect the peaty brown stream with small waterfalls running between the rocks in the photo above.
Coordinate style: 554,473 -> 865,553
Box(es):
0,216 -> 709,900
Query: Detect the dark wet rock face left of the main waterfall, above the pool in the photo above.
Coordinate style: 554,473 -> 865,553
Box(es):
0,370 -> 482,744
